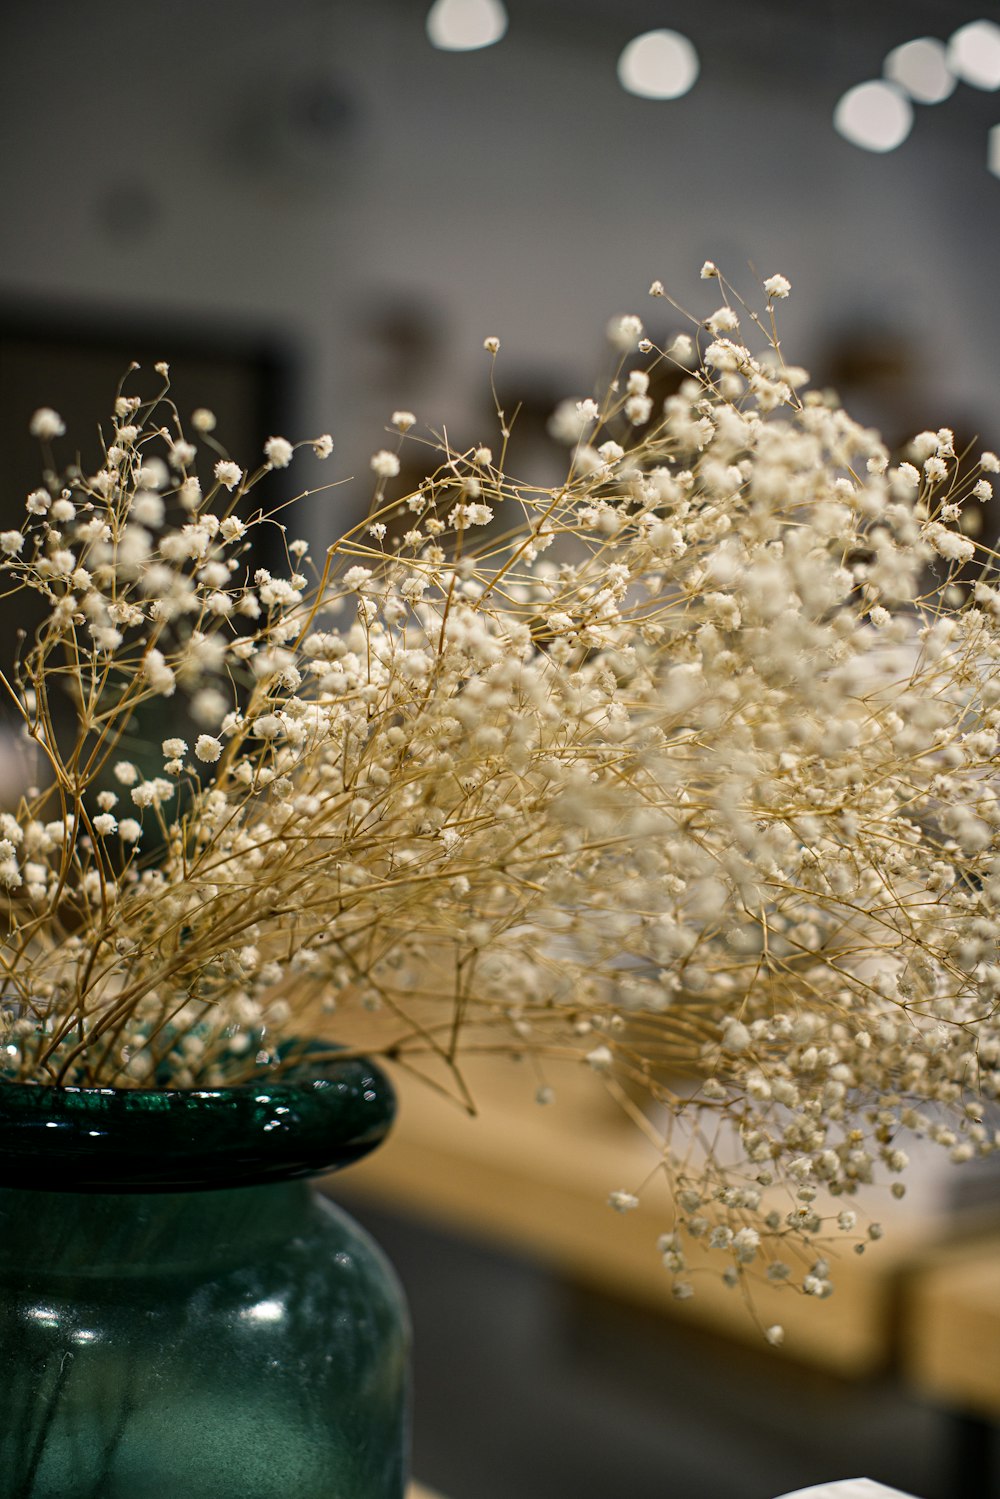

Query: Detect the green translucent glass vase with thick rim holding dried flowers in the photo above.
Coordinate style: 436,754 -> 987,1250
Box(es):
0,1052 -> 408,1499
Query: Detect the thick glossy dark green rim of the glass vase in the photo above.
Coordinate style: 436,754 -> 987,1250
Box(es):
0,1042 -> 396,1192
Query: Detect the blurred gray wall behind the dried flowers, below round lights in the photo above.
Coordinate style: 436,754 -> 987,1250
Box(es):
0,0 -> 1000,527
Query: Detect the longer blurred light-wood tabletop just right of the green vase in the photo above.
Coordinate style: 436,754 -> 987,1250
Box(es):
333,1058 -> 1000,1388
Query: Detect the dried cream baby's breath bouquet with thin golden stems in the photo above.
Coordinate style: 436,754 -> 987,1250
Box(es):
0,264 -> 1000,1340
